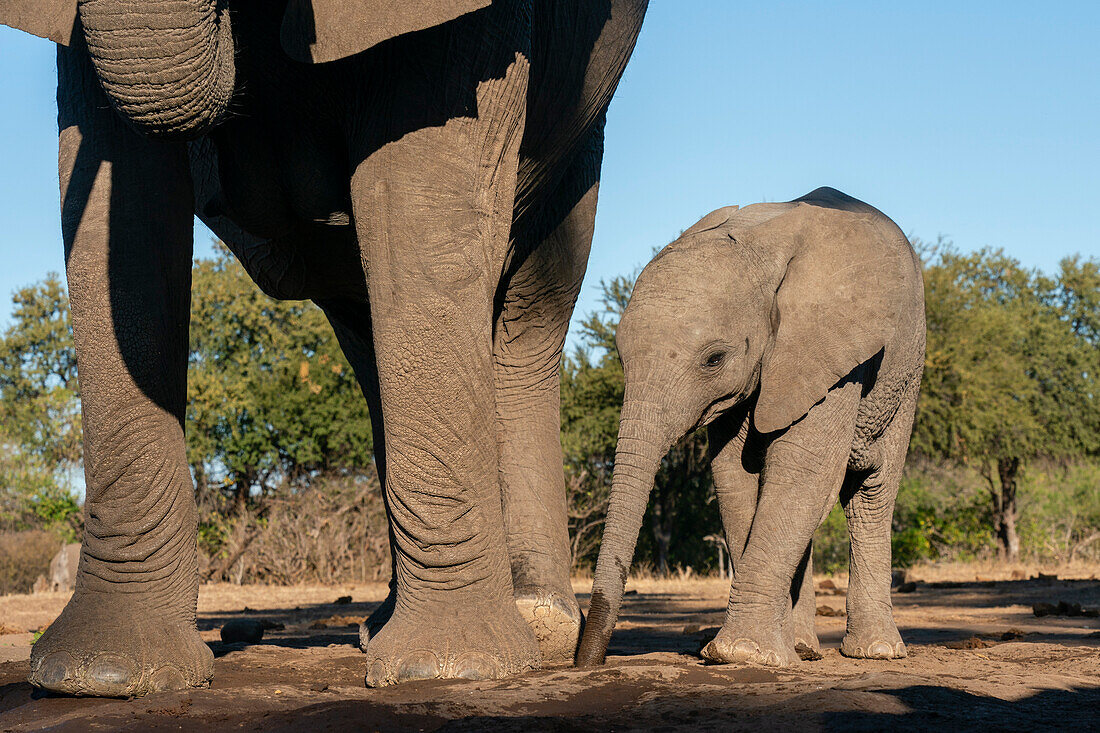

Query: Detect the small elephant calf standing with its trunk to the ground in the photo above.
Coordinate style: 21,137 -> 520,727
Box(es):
578,188 -> 925,666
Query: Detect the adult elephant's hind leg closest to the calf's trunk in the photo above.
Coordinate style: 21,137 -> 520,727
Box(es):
493,124 -> 603,663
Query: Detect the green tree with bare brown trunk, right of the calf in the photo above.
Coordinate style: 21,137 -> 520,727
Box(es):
913,248 -> 1100,561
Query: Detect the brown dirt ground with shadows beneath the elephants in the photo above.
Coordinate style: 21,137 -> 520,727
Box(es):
0,567 -> 1100,733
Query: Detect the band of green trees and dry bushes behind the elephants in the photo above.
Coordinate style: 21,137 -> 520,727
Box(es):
0,240 -> 1100,592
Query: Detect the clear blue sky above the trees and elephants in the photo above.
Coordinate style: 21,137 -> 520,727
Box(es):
0,0 -> 1100,345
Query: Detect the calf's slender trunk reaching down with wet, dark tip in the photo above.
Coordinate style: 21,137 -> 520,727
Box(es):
576,383 -> 679,667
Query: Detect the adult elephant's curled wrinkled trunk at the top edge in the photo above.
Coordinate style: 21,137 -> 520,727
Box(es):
79,0 -> 235,140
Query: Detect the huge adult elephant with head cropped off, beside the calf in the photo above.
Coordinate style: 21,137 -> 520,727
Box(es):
0,0 -> 647,696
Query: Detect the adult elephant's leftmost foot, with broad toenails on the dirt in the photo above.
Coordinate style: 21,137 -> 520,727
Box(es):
28,591 -> 213,698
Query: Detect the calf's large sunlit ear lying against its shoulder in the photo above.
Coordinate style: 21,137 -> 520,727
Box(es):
752,207 -> 908,433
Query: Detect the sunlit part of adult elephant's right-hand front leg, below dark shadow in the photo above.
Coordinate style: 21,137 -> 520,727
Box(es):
352,21 -> 539,687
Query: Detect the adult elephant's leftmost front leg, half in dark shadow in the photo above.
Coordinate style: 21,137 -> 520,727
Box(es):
30,42 -> 213,697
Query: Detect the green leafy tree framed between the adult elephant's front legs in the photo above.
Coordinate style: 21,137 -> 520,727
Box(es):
187,243 -> 372,512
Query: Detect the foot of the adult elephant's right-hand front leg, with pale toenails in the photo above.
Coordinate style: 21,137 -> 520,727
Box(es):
366,603 -> 539,687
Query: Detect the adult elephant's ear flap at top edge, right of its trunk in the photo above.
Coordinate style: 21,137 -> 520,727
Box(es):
283,0 -> 491,64
